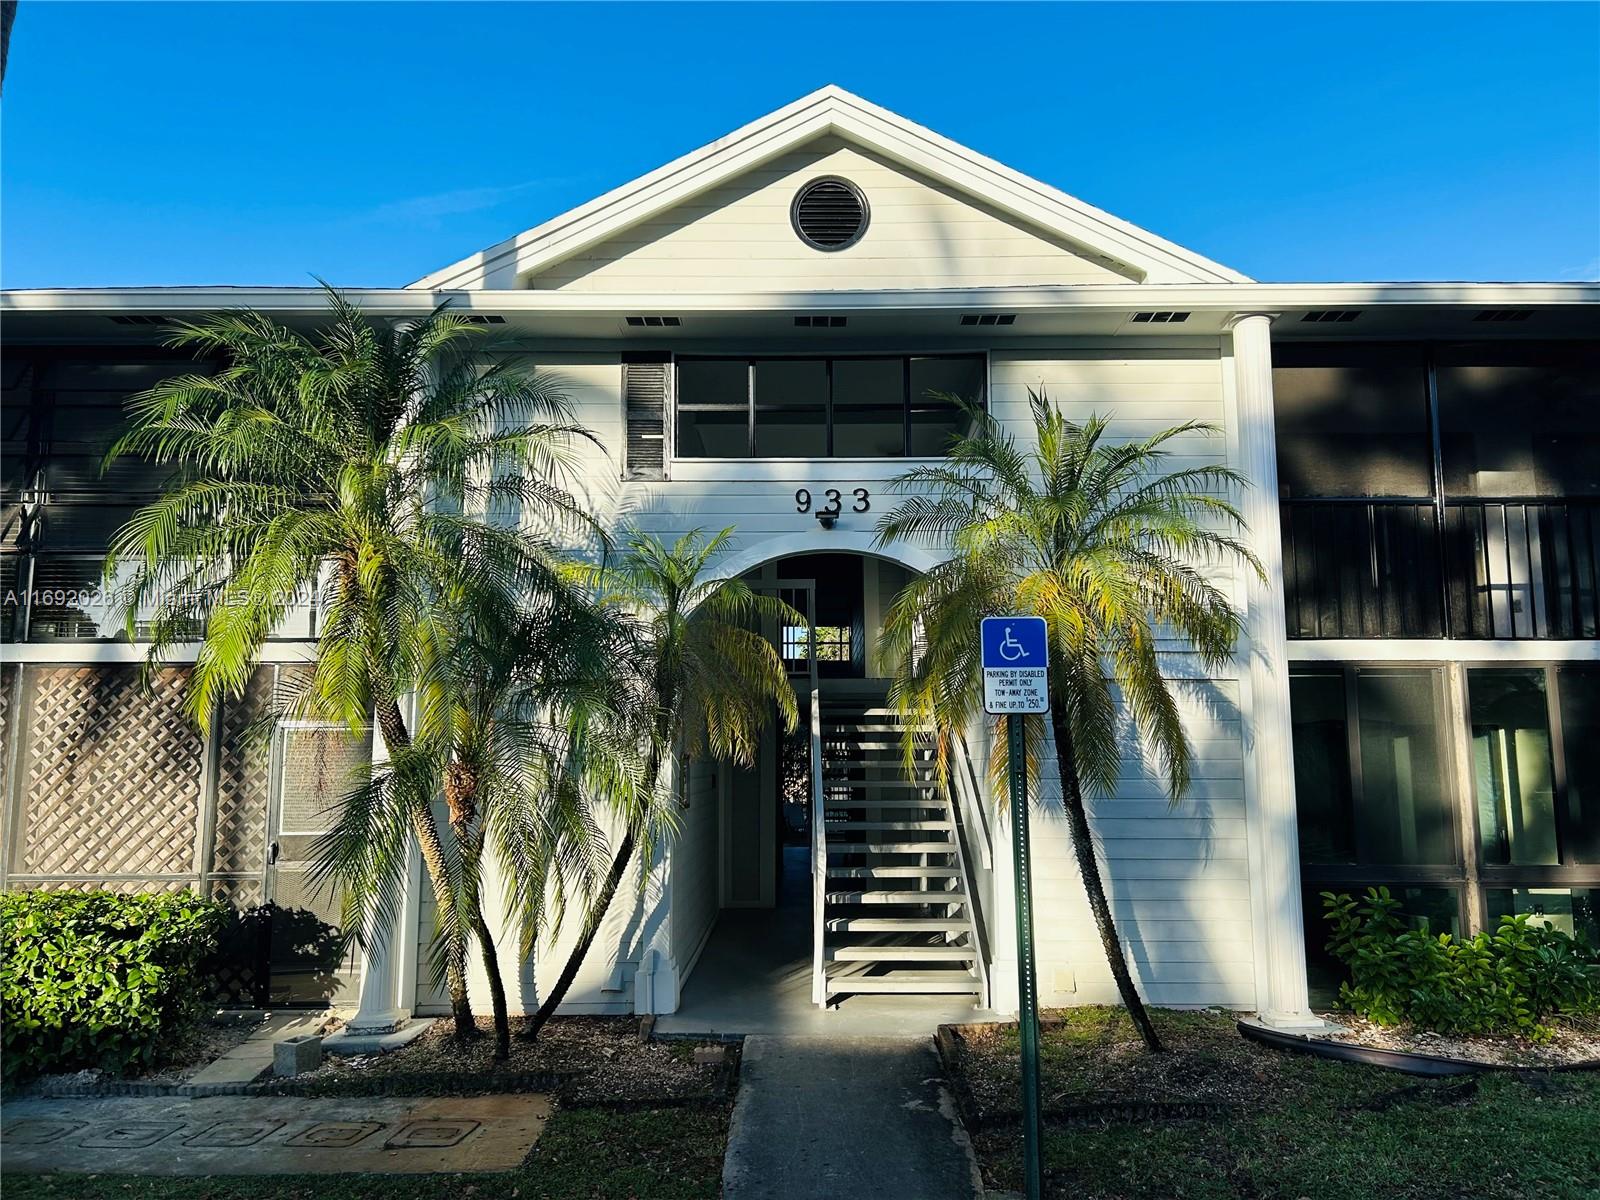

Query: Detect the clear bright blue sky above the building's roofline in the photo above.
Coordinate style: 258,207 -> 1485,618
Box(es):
0,0 -> 1600,286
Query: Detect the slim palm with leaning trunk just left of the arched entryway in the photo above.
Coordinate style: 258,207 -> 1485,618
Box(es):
523,528 -> 805,1040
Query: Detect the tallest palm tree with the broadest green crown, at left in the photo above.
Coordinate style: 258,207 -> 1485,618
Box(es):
106,288 -> 587,1035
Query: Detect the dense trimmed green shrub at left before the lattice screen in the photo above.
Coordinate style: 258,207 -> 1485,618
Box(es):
0,891 -> 224,1077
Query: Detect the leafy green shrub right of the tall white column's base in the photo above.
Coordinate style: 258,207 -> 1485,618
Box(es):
1322,888 -> 1600,1038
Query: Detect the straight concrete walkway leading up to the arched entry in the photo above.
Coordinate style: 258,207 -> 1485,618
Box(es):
722,1035 -> 979,1200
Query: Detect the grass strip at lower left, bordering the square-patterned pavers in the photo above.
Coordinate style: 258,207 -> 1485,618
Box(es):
3,1104 -> 730,1200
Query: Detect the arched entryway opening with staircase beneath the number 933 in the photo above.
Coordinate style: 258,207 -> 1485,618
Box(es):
658,541 -> 982,1034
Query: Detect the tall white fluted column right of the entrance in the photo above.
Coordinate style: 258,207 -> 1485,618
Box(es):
1230,312 -> 1323,1030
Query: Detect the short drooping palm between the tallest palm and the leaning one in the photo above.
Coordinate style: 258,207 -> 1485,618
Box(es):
314,590 -> 640,1058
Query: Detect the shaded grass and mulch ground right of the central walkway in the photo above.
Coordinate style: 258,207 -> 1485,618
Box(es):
962,1010 -> 1600,1200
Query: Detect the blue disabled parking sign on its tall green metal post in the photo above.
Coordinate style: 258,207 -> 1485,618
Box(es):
979,616 -> 1050,1200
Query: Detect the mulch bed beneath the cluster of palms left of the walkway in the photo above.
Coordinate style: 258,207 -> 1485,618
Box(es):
299,1016 -> 734,1104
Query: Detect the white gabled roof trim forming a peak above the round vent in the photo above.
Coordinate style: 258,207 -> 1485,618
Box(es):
410,85 -> 1250,290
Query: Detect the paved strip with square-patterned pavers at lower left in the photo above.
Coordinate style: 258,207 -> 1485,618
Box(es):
0,1094 -> 550,1174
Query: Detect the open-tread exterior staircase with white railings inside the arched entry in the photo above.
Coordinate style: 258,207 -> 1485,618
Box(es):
811,694 -> 984,1005
